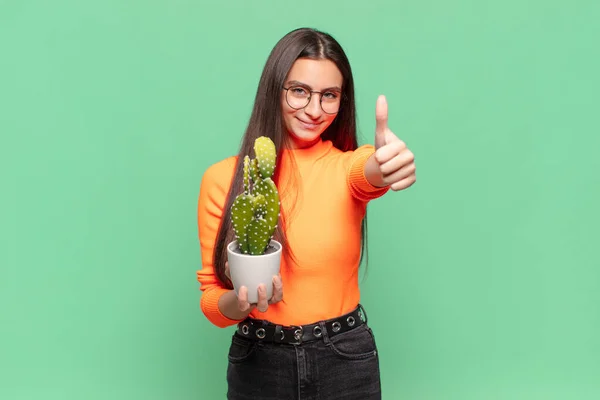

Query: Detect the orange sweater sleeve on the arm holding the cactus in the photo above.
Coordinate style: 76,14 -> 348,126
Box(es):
196,158 -> 245,328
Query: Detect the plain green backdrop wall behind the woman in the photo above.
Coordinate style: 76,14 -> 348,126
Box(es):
0,0 -> 600,400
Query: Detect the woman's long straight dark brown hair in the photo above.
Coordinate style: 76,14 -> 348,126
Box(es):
213,28 -> 367,289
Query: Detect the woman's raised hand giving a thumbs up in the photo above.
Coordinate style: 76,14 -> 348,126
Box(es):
367,96 -> 417,191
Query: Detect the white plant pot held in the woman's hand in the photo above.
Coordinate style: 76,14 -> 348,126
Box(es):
227,240 -> 282,304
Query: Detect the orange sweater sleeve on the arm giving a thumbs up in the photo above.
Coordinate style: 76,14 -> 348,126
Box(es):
347,144 -> 390,203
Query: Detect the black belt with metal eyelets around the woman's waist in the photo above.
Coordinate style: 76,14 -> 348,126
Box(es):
237,304 -> 367,344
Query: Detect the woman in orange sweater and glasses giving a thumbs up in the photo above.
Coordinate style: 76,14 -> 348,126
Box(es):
197,29 -> 416,400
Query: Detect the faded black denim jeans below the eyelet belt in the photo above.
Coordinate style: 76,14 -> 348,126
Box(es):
227,316 -> 381,400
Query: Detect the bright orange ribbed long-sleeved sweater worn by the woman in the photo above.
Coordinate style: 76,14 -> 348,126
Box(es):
197,141 -> 389,327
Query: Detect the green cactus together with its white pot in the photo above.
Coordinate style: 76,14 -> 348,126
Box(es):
227,136 -> 282,304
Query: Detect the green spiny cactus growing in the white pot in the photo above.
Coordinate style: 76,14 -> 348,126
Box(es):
231,136 -> 280,255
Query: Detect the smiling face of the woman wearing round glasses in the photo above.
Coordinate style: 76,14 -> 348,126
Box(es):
281,58 -> 343,148
